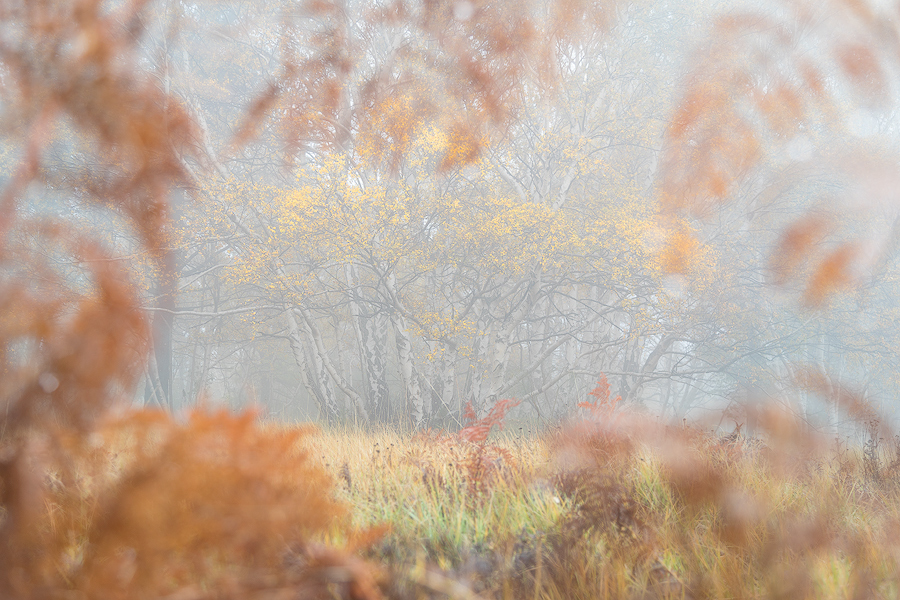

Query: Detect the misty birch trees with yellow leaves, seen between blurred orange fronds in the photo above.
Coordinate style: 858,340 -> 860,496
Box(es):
7,1 -> 900,427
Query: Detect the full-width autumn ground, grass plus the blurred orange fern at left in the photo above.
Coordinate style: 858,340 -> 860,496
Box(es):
10,410 -> 900,600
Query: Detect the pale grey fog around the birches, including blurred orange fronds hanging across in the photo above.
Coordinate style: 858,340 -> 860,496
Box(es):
3,0 -> 900,435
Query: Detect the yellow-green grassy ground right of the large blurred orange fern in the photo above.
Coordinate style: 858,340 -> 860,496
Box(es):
311,424 -> 900,599
